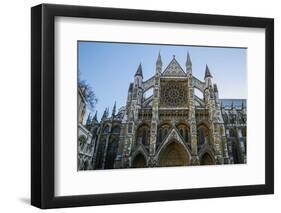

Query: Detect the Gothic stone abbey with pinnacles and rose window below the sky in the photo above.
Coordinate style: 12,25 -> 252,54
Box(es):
77,53 -> 247,170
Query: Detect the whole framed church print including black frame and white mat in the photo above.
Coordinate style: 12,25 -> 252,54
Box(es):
31,4 -> 274,208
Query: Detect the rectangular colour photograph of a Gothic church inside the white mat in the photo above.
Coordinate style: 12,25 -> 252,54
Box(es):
77,40 -> 247,171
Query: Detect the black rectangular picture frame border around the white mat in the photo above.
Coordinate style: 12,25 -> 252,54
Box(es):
31,4 -> 274,209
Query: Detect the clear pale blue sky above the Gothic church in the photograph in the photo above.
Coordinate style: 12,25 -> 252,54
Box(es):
78,41 -> 247,119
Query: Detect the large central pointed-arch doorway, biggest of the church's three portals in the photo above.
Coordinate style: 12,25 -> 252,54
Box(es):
159,142 -> 189,167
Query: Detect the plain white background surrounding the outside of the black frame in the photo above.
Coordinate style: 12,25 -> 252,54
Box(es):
0,0 -> 281,213
